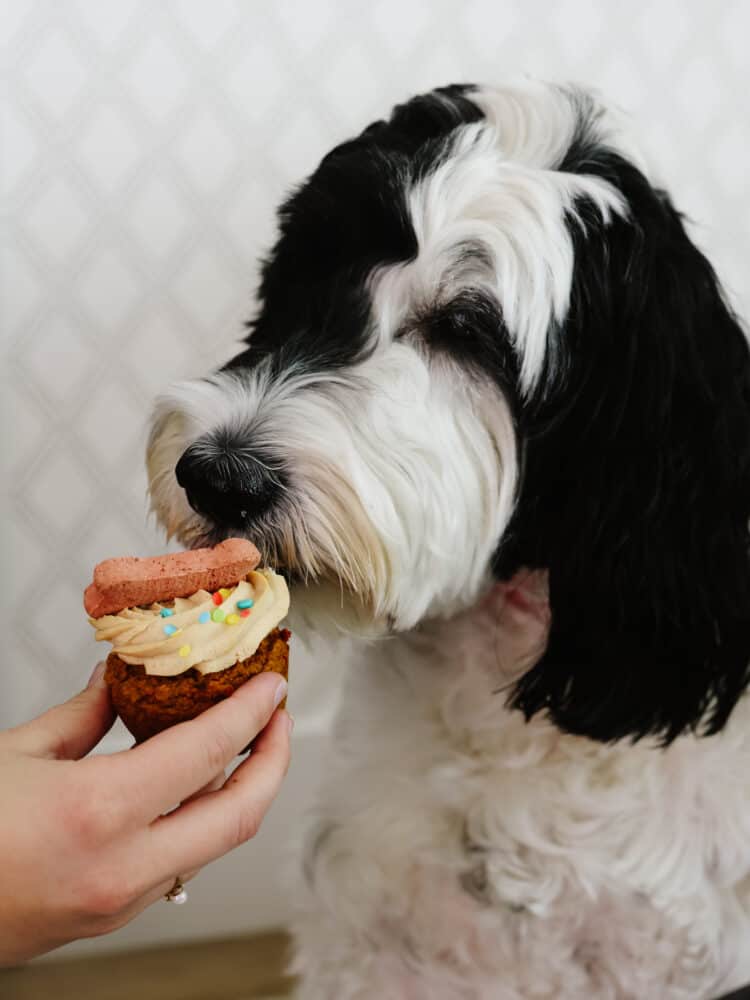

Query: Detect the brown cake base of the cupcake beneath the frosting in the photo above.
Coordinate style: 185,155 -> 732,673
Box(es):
104,629 -> 289,743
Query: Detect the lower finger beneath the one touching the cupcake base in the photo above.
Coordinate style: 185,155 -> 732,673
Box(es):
145,711 -> 291,871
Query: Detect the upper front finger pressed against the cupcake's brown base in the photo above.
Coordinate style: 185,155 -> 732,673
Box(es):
107,673 -> 286,823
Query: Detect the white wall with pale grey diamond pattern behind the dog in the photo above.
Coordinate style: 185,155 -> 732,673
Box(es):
0,0 -> 750,947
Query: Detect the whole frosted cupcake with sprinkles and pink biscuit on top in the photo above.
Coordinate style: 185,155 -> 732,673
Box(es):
84,539 -> 290,743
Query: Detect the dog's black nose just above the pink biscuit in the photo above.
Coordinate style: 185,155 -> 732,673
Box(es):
175,439 -> 281,527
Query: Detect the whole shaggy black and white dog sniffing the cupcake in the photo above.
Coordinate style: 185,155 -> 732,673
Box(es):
148,83 -> 750,1000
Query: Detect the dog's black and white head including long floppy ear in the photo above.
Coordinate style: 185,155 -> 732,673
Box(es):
149,84 -> 750,740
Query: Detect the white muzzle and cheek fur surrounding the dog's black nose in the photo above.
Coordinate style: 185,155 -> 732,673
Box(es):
149,342 -> 516,629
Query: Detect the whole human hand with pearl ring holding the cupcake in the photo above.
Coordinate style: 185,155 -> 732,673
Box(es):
0,664 -> 292,966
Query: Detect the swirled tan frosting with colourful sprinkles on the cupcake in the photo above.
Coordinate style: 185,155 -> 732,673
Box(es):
89,569 -> 289,677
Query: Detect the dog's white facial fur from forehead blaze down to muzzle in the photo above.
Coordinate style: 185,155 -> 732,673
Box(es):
149,84 -> 626,629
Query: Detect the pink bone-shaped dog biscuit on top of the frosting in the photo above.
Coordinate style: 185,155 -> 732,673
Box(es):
83,538 -> 260,618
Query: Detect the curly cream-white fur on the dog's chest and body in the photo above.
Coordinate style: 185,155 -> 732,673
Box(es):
296,593 -> 750,1000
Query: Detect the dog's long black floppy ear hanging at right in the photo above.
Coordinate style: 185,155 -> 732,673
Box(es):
496,150 -> 750,742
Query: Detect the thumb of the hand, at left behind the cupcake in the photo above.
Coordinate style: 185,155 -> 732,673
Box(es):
12,663 -> 115,760
